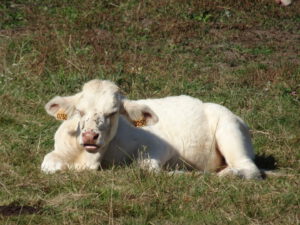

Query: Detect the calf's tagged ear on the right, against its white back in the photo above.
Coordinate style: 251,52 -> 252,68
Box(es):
120,99 -> 159,126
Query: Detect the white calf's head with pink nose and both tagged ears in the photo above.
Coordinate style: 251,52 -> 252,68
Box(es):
45,80 -> 158,152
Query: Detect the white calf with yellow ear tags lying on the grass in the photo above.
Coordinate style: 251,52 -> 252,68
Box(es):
42,80 -> 261,179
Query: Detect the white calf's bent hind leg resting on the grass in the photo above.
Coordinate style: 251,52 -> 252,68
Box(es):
216,118 -> 261,179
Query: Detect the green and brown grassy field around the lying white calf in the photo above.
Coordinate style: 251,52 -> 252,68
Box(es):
0,0 -> 300,225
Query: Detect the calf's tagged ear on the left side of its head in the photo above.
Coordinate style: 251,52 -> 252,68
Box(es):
45,94 -> 79,120
